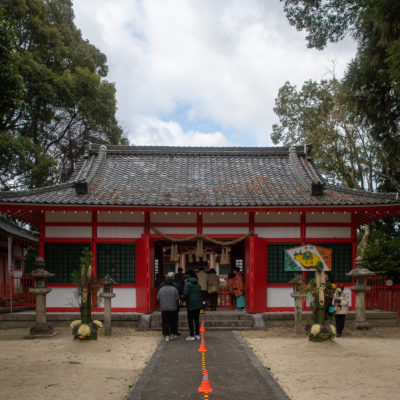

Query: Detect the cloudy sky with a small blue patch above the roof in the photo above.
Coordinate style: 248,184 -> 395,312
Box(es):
73,0 -> 355,146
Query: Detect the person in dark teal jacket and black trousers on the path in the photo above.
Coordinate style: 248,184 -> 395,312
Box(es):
183,271 -> 203,340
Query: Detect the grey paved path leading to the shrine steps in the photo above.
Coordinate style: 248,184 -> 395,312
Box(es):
127,331 -> 289,400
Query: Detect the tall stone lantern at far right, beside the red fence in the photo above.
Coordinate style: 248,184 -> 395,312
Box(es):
346,256 -> 375,329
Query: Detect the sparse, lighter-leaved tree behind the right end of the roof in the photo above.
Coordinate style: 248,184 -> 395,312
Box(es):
271,79 -> 379,190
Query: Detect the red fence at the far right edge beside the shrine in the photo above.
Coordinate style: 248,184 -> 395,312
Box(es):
365,275 -> 400,318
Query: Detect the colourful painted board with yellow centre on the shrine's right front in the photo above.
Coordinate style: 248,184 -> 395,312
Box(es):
285,244 -> 332,271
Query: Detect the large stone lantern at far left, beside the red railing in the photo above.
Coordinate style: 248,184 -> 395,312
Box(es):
29,257 -> 54,338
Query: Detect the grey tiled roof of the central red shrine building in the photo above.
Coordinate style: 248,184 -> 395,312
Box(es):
0,144 -> 400,207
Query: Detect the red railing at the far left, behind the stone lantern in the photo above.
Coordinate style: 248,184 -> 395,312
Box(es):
0,277 -> 35,308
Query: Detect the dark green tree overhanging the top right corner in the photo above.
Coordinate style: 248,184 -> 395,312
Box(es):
283,0 -> 400,190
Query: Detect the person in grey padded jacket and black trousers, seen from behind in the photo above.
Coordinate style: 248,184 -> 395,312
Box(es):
157,278 -> 179,342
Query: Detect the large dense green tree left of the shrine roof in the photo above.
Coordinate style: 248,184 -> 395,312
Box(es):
0,0 -> 126,189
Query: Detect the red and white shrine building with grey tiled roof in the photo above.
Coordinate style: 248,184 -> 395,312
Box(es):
0,143 -> 400,313
